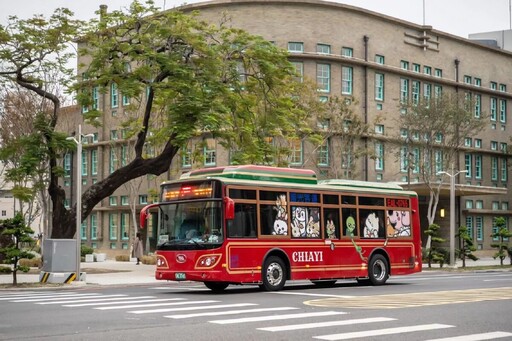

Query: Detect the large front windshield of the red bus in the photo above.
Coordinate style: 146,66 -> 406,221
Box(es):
157,200 -> 224,250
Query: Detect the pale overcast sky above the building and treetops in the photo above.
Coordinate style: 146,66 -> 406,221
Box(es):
0,0 -> 512,38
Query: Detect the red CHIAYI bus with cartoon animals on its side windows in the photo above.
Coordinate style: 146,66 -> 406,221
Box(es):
141,165 -> 422,291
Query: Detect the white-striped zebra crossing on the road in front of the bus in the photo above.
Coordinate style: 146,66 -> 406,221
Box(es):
0,291 -> 512,341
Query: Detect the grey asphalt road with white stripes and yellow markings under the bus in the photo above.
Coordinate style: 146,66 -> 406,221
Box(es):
0,272 -> 512,341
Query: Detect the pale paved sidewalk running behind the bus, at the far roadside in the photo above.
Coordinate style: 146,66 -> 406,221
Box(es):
0,257 -> 510,286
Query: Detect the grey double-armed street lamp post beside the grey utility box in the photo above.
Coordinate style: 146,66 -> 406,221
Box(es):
67,124 -> 93,281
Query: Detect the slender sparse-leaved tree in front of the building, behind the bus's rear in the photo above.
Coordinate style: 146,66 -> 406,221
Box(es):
396,93 -> 487,248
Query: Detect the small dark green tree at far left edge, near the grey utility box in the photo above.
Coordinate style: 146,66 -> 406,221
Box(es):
0,213 -> 34,285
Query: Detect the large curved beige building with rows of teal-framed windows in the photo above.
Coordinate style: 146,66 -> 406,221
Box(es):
63,0 -> 512,254
